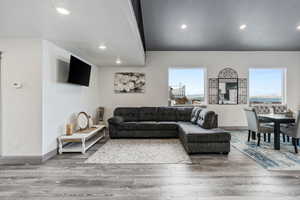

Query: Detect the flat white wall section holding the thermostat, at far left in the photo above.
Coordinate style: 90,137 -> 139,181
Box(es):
0,38 -> 42,156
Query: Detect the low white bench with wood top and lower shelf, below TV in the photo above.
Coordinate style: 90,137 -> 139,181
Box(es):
58,125 -> 106,154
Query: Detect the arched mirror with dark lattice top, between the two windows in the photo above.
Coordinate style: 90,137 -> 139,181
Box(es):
218,68 -> 238,104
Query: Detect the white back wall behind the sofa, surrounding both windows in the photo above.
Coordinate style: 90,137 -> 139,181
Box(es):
100,51 -> 300,126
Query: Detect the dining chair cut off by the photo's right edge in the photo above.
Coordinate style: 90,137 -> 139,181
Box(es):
280,110 -> 300,153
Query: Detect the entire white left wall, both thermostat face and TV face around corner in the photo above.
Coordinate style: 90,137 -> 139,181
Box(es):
0,38 -> 100,157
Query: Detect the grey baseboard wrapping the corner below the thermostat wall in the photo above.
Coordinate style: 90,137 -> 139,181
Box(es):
0,149 -> 57,165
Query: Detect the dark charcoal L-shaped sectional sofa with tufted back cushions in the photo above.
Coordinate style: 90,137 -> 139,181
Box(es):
108,107 -> 231,154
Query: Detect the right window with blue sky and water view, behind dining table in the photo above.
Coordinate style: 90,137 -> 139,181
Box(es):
249,69 -> 285,104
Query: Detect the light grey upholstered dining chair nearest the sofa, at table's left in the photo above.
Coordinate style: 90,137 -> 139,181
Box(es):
244,108 -> 274,146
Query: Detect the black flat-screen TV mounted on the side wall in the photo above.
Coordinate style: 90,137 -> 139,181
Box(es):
68,56 -> 92,86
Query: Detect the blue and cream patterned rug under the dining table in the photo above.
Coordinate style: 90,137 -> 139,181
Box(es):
231,131 -> 300,170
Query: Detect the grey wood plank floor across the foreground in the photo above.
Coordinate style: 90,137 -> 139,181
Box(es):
0,133 -> 300,200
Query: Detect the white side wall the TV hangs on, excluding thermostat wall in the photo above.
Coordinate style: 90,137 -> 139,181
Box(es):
43,41 -> 100,154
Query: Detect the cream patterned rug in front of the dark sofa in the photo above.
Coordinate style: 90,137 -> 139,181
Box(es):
85,139 -> 192,164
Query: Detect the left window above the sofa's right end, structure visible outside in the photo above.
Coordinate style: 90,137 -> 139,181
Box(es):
169,68 -> 204,106
